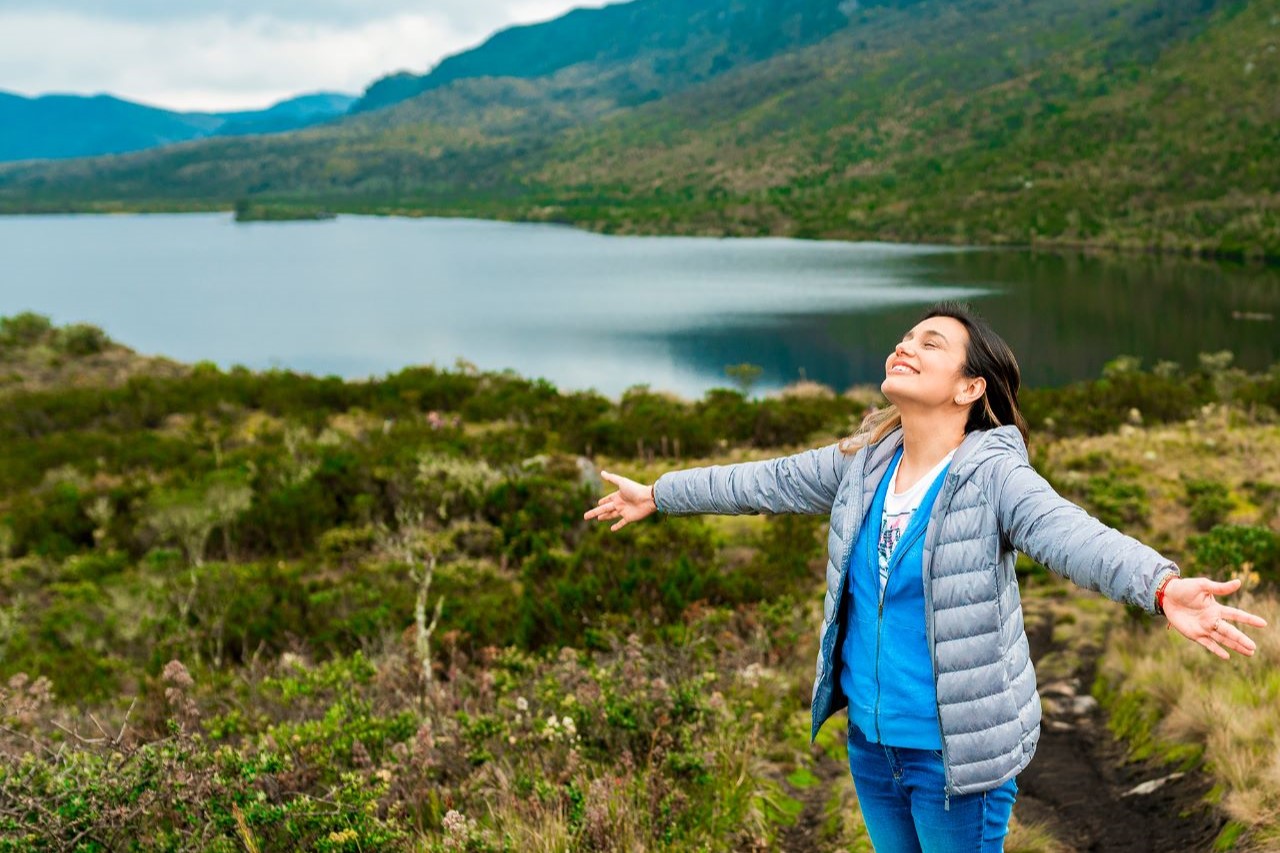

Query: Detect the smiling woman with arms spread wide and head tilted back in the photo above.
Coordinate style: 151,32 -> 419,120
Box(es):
585,304 -> 1266,853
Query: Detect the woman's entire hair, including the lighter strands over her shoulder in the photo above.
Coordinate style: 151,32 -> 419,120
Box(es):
840,301 -> 1028,453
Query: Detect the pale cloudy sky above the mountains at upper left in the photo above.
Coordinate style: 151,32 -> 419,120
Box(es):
0,0 -> 604,110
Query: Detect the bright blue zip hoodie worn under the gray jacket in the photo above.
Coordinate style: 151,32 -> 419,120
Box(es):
840,447 -> 950,749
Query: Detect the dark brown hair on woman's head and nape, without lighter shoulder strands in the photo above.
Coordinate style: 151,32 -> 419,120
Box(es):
920,301 -> 1028,443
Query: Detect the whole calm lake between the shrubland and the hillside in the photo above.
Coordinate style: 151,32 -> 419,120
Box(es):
0,214 -> 1280,396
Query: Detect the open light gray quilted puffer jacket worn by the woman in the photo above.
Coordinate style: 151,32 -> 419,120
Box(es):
654,427 -> 1178,797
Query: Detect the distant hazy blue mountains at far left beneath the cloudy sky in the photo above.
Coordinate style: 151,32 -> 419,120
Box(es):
0,92 -> 356,160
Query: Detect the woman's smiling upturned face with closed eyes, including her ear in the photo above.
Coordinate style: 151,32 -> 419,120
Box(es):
881,316 -> 986,409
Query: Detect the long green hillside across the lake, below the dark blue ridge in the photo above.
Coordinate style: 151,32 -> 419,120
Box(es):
0,0 -> 1280,257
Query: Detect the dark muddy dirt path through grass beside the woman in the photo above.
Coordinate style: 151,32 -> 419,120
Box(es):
1015,601 -> 1224,853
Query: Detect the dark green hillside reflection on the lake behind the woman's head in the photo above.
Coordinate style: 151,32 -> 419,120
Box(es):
666,251 -> 1280,388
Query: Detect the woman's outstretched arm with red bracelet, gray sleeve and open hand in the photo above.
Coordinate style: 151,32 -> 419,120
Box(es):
996,460 -> 1266,658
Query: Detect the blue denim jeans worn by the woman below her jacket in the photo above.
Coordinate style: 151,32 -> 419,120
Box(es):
849,725 -> 1018,853
